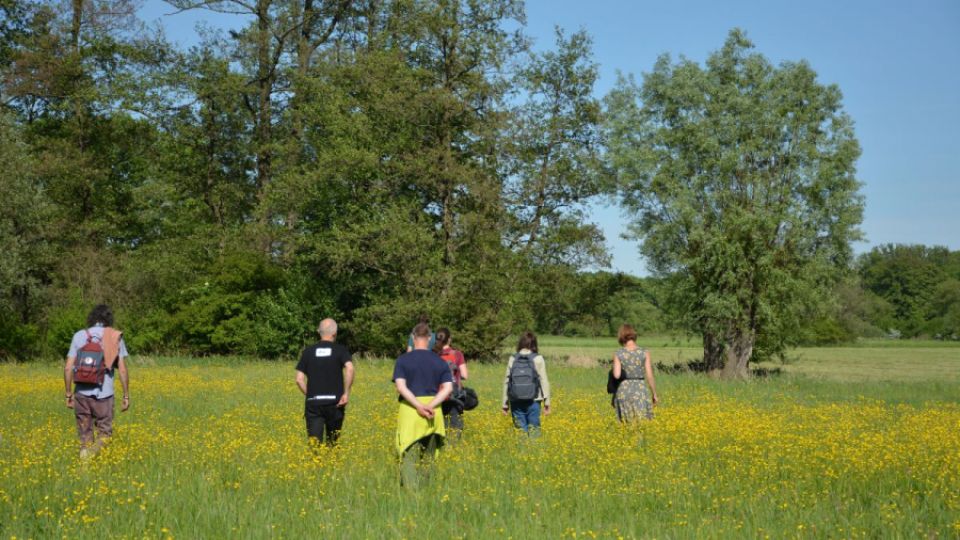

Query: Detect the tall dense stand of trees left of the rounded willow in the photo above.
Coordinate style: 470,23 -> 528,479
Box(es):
0,0 -> 606,357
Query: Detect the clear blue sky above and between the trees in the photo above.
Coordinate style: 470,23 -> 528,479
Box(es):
141,0 -> 960,275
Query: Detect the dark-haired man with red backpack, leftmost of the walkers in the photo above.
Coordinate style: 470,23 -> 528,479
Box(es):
63,304 -> 130,458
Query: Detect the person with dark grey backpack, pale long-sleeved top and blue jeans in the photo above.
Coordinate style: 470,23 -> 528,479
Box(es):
502,332 -> 550,437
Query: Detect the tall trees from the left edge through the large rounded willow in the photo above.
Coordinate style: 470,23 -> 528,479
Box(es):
0,0 -> 892,376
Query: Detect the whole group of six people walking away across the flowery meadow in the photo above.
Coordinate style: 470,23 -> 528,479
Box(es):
64,305 -> 659,487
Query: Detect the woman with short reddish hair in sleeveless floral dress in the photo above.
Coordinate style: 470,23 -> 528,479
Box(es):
613,324 -> 659,422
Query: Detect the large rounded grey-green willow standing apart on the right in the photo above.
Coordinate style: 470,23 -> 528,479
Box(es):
607,30 -> 863,377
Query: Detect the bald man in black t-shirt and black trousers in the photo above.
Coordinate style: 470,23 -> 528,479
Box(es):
297,319 -> 353,446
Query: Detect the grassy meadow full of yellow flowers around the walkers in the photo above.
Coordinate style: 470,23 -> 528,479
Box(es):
0,358 -> 960,539
